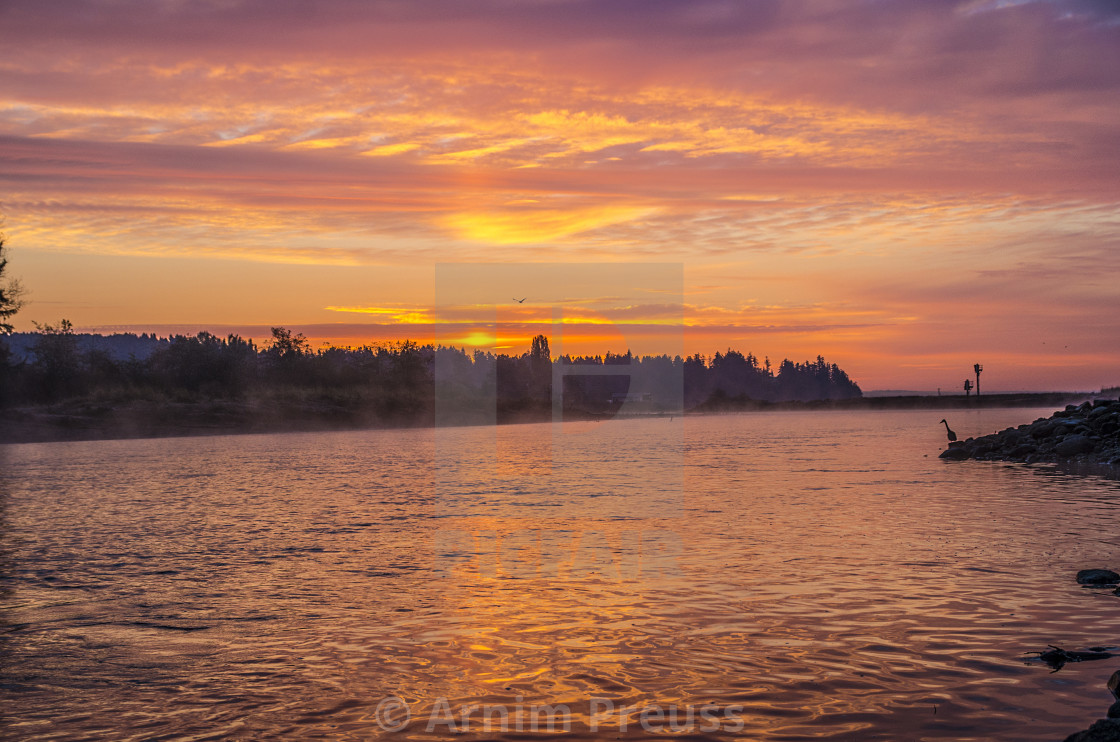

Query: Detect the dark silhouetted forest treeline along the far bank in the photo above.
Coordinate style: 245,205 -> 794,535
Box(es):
0,321 -> 861,439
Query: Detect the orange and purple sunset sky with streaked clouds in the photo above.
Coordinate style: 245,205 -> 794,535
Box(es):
0,0 -> 1120,391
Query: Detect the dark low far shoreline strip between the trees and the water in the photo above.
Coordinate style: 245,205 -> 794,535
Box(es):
0,392 -> 1094,445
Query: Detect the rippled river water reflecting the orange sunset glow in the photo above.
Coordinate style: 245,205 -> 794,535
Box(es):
0,410 -> 1120,741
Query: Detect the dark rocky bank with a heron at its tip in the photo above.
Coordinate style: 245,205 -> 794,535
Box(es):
941,399 -> 1120,466
